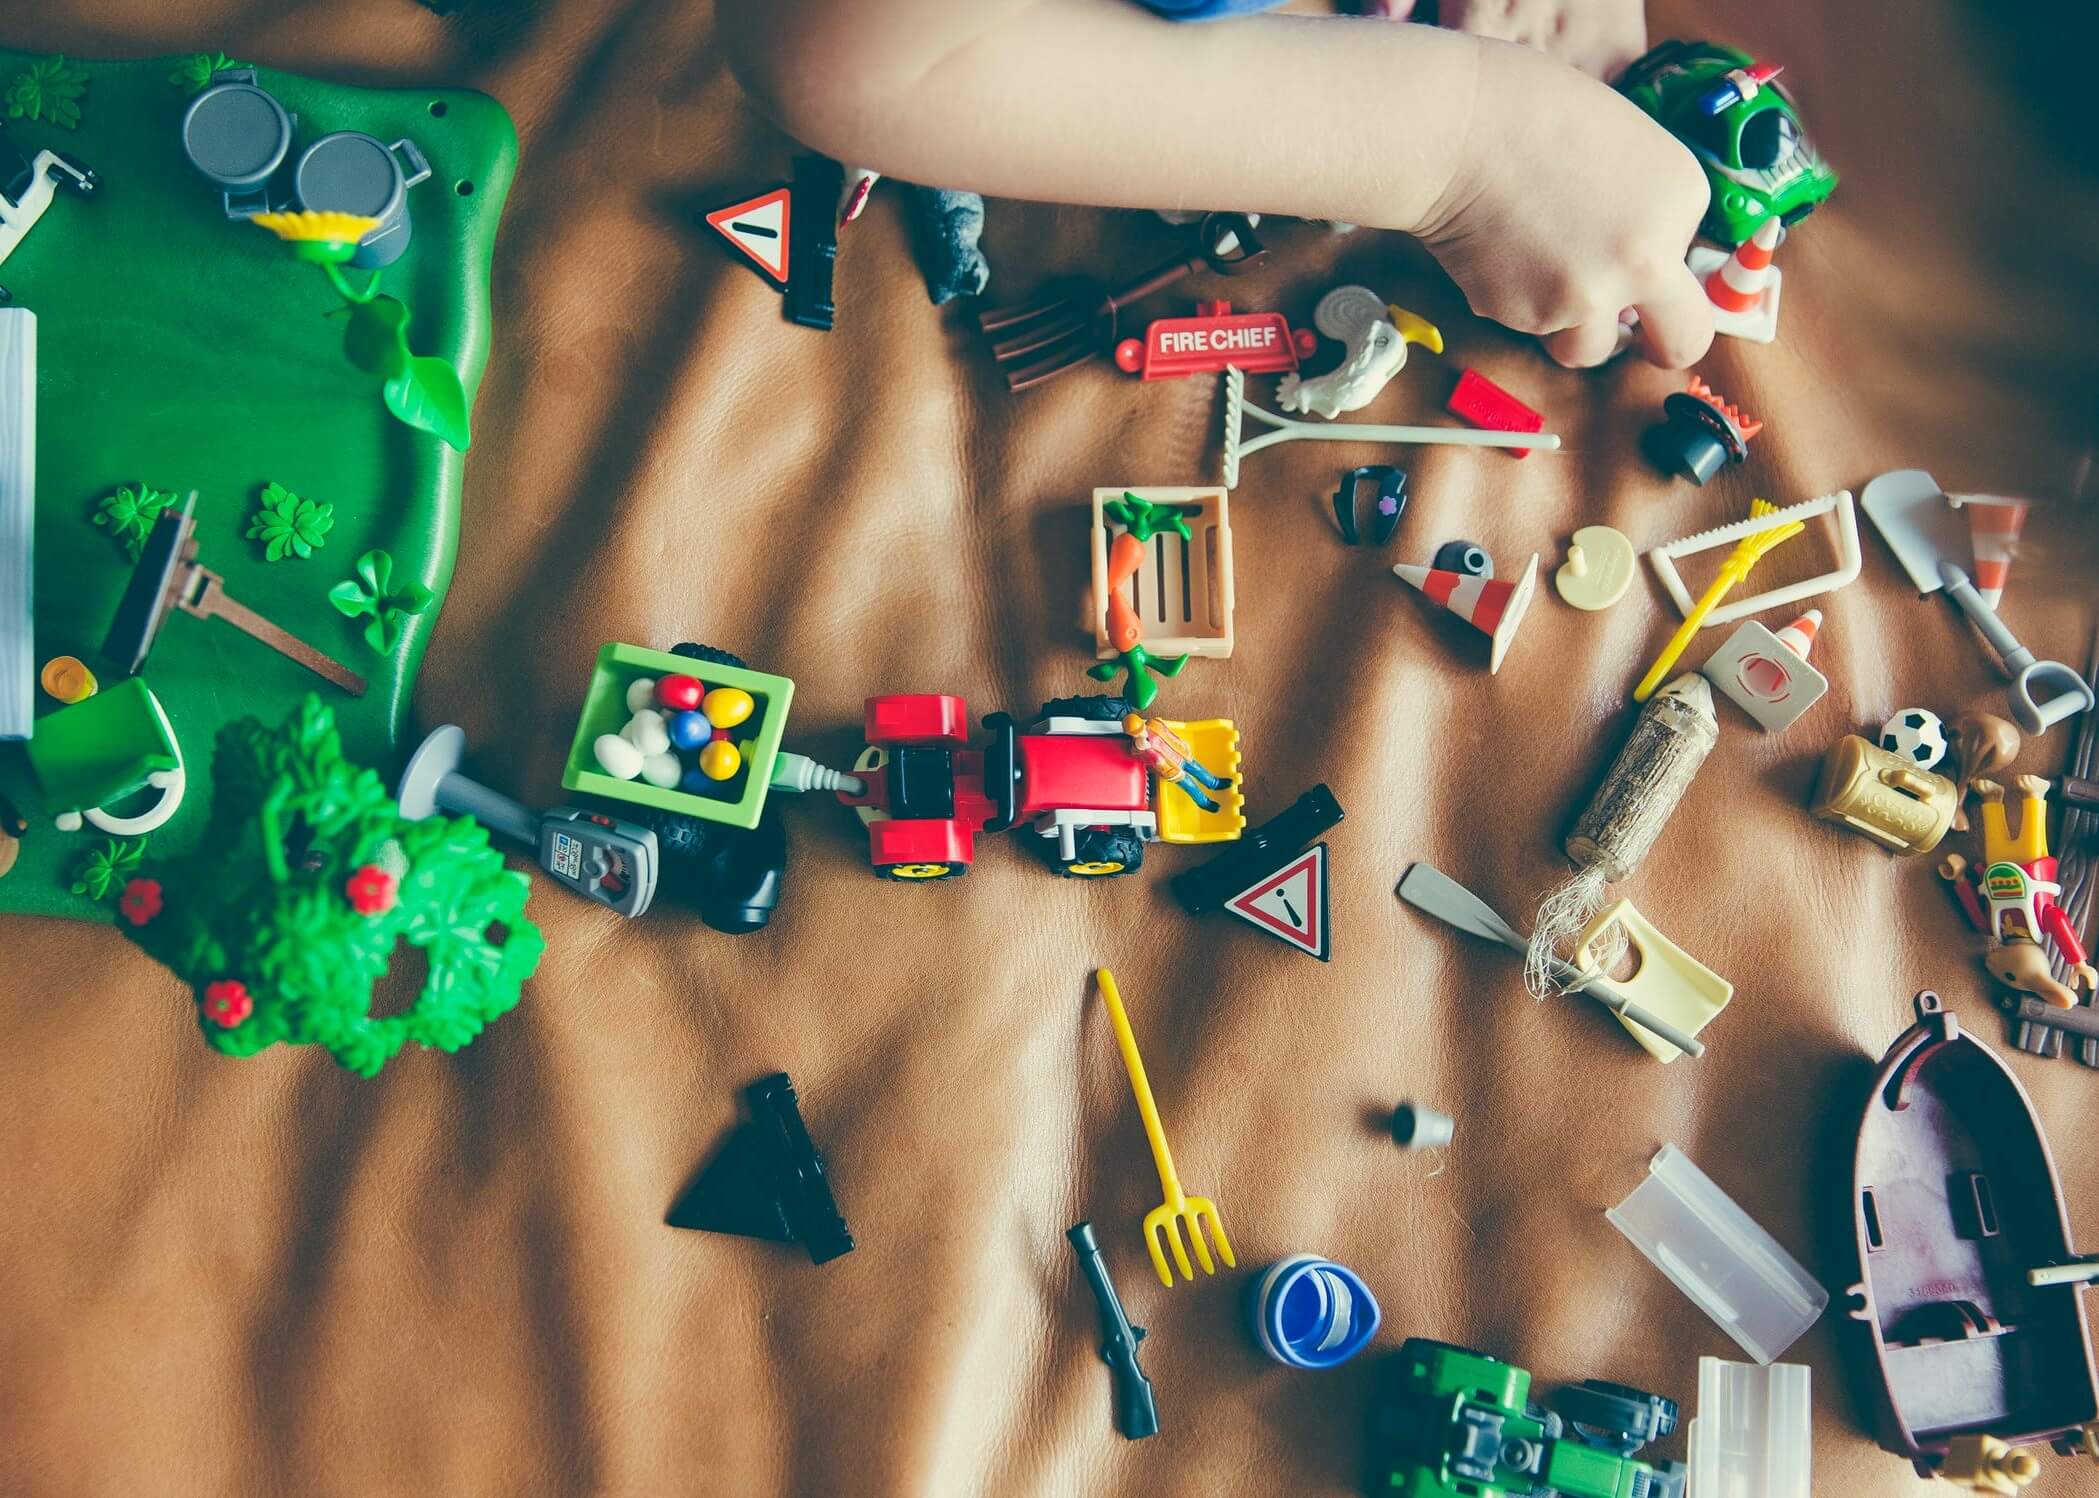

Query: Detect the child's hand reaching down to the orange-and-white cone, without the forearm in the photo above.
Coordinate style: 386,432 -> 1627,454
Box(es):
1419,42 -> 1713,369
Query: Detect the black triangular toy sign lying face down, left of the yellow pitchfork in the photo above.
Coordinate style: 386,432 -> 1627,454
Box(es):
665,1072 -> 852,1263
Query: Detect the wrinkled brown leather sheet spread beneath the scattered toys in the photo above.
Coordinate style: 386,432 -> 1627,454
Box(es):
0,0 -> 2099,1498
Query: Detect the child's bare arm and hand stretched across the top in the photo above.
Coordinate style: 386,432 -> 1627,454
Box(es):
718,0 -> 1713,365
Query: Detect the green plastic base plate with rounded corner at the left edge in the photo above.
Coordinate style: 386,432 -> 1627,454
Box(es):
0,48 -> 516,919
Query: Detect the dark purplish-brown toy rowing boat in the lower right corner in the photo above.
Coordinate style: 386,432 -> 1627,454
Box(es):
1851,992 -> 2099,1477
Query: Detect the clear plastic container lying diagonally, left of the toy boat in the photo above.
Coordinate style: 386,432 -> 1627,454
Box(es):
1604,1143 -> 1830,1364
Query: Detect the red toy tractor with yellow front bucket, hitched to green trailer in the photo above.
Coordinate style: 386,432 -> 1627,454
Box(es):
838,692 -> 1247,881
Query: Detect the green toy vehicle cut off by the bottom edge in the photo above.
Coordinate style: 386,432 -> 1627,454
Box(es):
1371,1336 -> 1685,1498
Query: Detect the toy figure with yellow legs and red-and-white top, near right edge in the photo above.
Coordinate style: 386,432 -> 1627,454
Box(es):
1939,774 -> 2099,1009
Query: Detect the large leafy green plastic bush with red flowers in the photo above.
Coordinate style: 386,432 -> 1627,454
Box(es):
118,694 -> 546,1076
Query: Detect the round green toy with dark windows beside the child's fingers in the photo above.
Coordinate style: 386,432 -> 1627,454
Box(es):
1618,42 -> 1837,250
